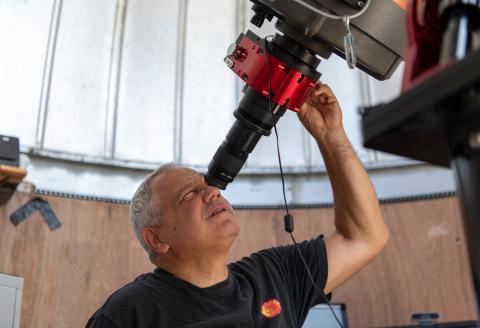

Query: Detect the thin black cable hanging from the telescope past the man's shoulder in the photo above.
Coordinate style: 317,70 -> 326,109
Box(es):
263,35 -> 344,328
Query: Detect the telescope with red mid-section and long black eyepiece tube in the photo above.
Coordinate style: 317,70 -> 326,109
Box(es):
205,0 -> 407,189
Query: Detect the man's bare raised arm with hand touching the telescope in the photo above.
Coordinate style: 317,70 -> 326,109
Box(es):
298,84 -> 388,293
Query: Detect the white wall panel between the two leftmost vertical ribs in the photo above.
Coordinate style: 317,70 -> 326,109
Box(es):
44,0 -> 116,156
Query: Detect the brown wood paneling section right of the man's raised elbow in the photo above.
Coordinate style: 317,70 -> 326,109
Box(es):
334,198 -> 476,327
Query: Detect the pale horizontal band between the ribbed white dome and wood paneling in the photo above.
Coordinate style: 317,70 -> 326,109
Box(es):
25,157 -> 455,206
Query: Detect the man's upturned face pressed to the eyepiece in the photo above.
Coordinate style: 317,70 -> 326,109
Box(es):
151,167 -> 240,257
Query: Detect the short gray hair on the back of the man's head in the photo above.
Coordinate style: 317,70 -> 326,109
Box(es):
130,163 -> 177,260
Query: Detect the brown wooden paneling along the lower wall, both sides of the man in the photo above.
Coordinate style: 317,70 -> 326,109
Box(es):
0,194 -> 475,328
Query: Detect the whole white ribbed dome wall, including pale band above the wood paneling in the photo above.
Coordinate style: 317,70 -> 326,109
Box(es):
0,0 -> 454,205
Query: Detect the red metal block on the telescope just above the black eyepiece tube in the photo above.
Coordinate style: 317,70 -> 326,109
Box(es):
225,35 -> 317,112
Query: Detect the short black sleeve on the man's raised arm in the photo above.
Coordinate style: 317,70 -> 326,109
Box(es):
253,235 -> 330,322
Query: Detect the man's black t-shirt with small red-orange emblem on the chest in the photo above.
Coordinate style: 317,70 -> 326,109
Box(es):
87,236 -> 328,328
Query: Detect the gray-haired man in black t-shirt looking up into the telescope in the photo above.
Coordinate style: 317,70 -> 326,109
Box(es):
87,85 -> 388,328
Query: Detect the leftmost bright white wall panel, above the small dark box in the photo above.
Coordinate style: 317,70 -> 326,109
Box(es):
0,0 -> 53,146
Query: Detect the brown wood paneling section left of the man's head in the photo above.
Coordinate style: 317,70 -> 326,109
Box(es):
0,194 -> 153,328
